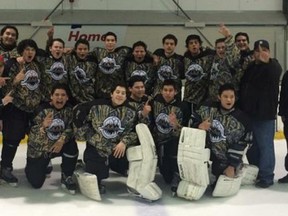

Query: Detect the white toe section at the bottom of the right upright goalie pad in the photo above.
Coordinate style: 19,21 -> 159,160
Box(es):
177,180 -> 207,200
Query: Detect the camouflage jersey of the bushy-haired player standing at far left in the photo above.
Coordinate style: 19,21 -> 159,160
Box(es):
3,59 -> 44,112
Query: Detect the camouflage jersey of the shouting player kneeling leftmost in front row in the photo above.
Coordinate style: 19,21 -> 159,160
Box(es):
27,103 -> 73,158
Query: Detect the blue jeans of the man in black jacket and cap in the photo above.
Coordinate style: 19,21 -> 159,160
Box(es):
247,119 -> 275,183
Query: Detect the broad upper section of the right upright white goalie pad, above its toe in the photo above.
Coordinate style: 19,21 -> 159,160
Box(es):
177,127 -> 210,187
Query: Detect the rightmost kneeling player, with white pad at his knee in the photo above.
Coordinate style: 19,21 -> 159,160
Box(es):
187,83 -> 252,196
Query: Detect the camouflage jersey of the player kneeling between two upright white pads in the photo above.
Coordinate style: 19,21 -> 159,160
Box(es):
151,94 -> 184,145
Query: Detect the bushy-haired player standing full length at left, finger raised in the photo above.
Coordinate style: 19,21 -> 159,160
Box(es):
1,39 -> 44,185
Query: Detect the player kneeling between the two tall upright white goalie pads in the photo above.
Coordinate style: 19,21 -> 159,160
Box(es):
151,80 -> 189,192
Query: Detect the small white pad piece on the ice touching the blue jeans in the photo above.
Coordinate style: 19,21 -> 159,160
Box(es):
240,164 -> 259,185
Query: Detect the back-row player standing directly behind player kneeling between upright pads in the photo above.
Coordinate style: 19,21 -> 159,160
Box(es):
153,34 -> 185,99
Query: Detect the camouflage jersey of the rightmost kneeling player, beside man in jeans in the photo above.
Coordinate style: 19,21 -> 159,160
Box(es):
193,103 -> 252,168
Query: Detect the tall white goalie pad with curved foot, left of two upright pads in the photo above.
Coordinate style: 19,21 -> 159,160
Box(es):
126,123 -> 162,201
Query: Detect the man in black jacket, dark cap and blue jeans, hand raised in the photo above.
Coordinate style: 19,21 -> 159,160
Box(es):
240,40 -> 282,188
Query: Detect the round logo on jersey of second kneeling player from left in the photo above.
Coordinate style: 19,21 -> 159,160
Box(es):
99,116 -> 124,139
